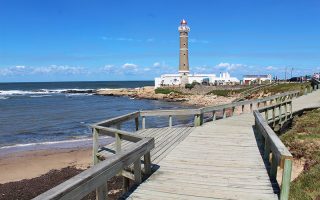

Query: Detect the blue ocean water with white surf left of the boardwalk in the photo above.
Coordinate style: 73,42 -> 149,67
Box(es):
0,81 -> 192,148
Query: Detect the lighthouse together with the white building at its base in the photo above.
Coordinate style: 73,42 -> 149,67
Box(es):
155,20 -> 239,88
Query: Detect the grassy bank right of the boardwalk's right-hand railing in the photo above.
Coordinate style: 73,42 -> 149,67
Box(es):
281,109 -> 320,200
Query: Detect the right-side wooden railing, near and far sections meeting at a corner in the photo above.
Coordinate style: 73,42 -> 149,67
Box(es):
253,100 -> 293,200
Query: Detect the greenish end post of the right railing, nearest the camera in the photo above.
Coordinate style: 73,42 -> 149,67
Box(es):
280,159 -> 292,200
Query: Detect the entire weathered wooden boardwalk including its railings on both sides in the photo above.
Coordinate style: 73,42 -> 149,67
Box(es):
35,89 -> 320,200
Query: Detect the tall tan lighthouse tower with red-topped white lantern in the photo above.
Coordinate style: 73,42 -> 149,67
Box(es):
178,19 -> 190,85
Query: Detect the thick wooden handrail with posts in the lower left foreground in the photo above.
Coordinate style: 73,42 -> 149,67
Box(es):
34,138 -> 154,200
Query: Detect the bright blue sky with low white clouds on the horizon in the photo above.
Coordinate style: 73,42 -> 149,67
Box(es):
0,0 -> 320,82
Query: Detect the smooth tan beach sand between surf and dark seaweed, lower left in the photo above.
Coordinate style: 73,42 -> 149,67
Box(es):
0,148 -> 92,183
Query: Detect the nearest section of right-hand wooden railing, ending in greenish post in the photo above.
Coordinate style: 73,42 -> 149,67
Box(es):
253,110 -> 293,200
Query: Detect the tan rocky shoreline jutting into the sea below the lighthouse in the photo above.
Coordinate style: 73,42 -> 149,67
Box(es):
95,86 -> 236,106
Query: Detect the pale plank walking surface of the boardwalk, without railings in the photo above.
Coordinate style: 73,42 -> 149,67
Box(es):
129,91 -> 320,200
